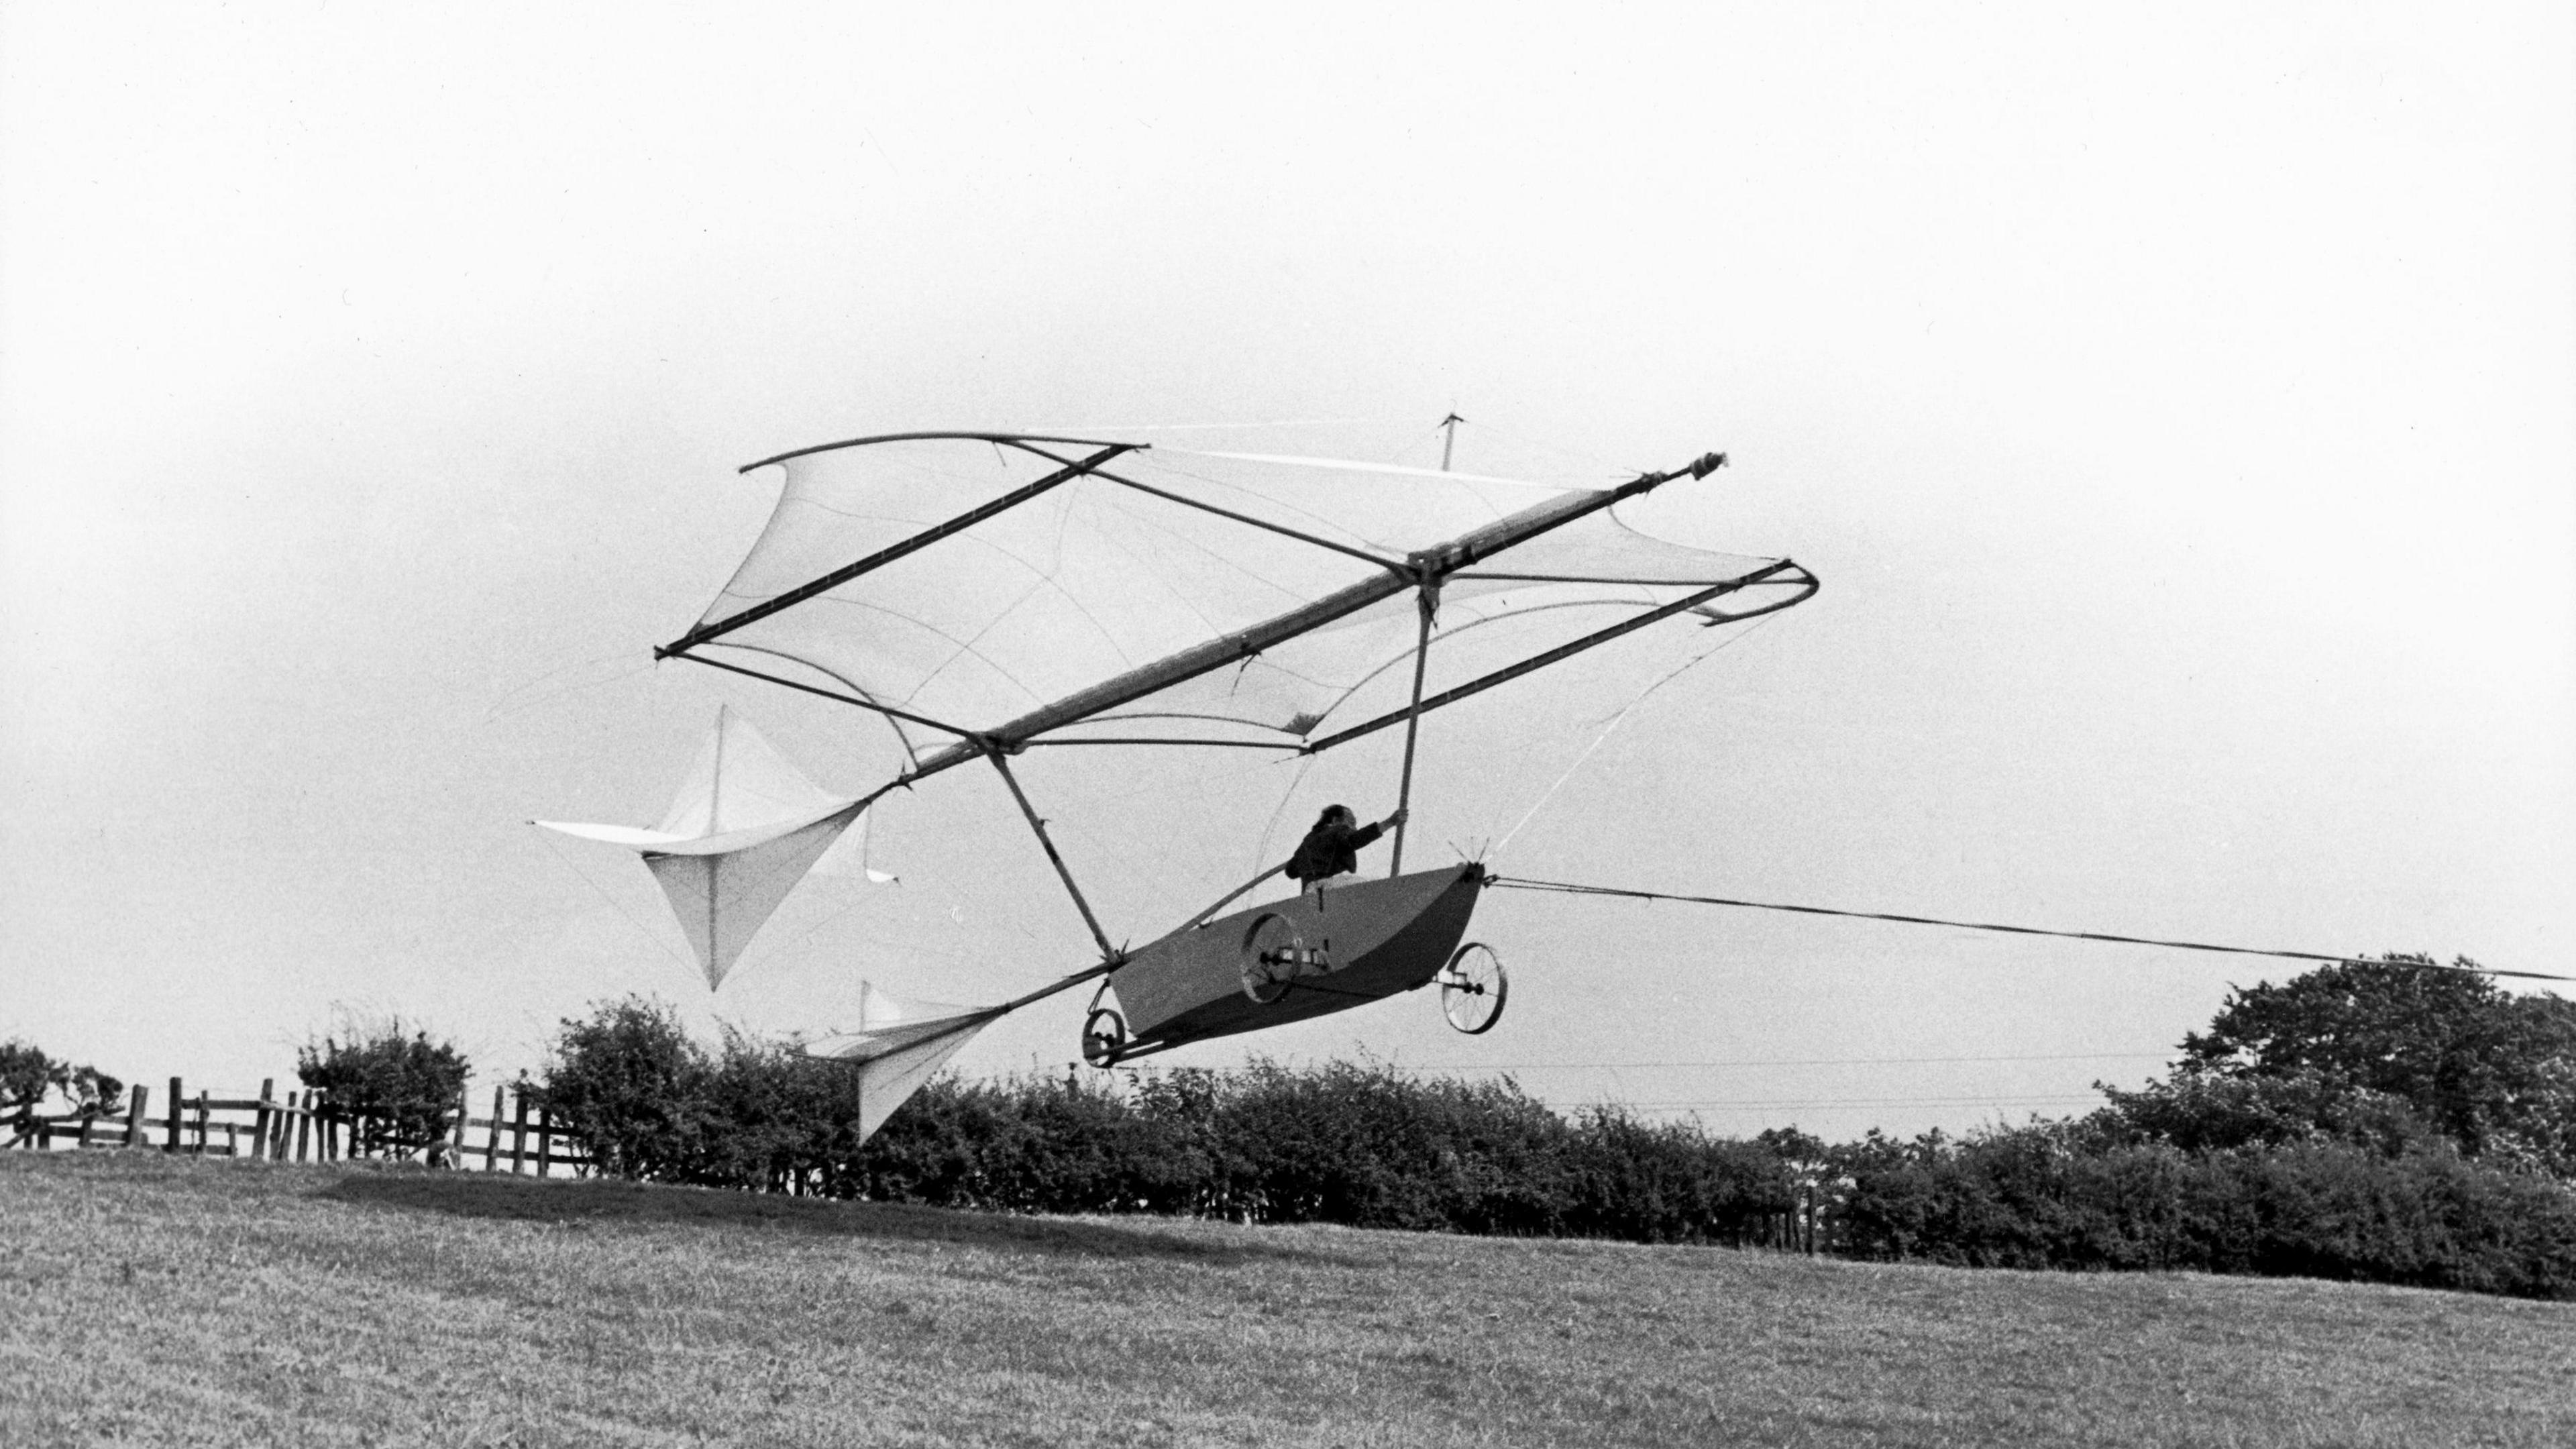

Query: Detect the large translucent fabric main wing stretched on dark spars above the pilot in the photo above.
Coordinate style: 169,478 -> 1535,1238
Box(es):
662,433 -> 1813,757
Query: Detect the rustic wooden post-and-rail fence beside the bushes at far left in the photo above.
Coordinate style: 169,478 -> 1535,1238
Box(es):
0,1078 -> 590,1178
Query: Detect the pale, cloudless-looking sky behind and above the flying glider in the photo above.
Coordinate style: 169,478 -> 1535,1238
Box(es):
0,5 -> 2576,1134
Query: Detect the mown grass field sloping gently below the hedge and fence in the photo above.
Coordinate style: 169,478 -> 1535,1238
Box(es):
0,1152 -> 2576,1449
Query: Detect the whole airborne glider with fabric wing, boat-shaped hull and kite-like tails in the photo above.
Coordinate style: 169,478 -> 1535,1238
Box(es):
556,423 -> 1816,1127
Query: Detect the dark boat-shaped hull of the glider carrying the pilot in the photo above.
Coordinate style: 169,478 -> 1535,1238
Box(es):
1110,864 -> 1484,1057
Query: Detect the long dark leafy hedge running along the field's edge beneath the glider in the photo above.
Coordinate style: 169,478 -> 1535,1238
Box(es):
541,969 -> 2576,1297
